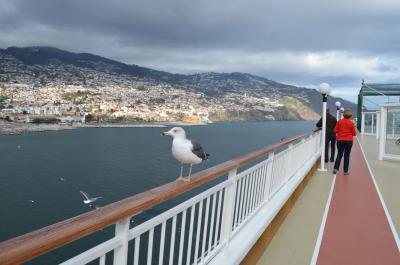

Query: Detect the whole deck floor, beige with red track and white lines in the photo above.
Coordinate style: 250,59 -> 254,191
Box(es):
258,136 -> 400,265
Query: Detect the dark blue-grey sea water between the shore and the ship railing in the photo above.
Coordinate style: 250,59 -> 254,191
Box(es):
0,121 -> 315,264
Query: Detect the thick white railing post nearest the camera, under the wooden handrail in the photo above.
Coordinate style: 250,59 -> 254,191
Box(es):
113,218 -> 130,265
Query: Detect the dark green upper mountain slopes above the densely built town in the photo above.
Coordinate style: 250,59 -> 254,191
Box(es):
0,46 -> 356,119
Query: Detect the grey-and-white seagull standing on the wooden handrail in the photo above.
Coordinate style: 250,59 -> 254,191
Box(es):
162,127 -> 210,181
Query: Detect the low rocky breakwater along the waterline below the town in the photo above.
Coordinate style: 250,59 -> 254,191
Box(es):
0,121 -> 206,135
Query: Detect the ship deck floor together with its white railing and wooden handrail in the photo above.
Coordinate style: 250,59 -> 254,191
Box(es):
0,131 -> 400,265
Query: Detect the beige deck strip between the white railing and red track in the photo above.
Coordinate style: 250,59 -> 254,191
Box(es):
257,163 -> 333,265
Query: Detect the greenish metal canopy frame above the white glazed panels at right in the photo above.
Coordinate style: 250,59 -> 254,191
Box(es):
357,80 -> 400,131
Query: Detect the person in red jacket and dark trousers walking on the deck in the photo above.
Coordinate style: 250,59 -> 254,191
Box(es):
333,109 -> 356,175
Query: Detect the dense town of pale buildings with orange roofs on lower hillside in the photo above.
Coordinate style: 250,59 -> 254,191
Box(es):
0,82 -> 282,123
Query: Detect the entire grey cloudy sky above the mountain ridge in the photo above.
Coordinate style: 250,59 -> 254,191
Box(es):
0,0 -> 400,100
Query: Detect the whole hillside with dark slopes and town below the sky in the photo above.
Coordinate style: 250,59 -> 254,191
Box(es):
0,47 -> 356,120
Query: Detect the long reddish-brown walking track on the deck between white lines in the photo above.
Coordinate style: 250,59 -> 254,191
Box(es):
317,140 -> 400,265
